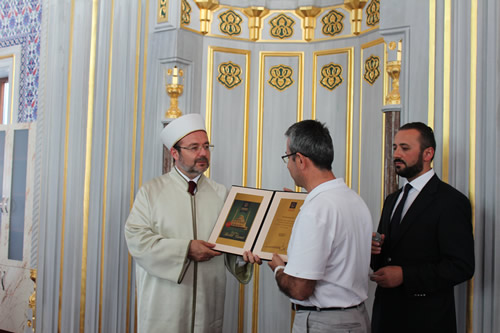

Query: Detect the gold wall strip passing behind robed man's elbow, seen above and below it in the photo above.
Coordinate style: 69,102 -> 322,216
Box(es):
125,0 -> 144,333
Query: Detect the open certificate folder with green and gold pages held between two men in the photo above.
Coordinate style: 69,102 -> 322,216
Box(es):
208,186 -> 307,260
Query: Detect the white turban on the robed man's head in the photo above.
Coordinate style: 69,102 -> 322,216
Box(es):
160,113 -> 206,149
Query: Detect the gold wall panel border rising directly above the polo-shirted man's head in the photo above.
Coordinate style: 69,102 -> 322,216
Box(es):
311,47 -> 354,187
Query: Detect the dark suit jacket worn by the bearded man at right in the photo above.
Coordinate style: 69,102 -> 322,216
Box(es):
371,175 -> 474,333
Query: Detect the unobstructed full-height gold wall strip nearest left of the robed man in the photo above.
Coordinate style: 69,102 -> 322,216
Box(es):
98,0 -> 115,333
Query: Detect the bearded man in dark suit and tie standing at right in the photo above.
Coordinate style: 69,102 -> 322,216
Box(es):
371,122 -> 474,333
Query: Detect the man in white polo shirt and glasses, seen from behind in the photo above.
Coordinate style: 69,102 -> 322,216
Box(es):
254,120 -> 372,333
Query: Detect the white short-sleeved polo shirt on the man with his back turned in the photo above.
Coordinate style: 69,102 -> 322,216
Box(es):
285,178 -> 373,308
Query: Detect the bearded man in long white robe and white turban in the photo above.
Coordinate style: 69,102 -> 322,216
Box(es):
125,114 -> 252,333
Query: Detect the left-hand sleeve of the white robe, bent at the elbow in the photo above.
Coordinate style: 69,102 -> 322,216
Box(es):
125,188 -> 191,283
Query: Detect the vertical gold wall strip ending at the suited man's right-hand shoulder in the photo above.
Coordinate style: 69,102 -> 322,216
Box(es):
442,0 -> 451,183
